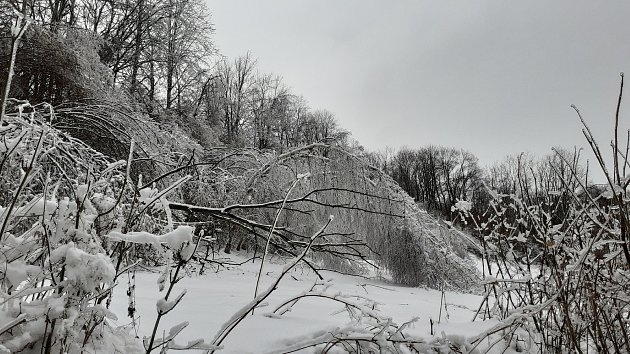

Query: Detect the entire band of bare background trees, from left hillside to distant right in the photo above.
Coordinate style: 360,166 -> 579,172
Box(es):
0,0 -> 595,227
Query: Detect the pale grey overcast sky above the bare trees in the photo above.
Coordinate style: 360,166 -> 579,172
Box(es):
207,0 -> 630,174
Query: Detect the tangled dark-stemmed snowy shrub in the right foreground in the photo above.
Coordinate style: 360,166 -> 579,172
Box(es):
460,84 -> 630,353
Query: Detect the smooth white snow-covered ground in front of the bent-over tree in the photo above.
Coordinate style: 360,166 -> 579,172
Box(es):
111,256 -> 495,353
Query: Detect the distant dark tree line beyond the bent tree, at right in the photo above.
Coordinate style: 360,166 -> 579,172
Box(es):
369,145 -> 601,224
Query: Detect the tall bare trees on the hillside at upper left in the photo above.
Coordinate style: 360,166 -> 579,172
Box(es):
0,0 -> 349,151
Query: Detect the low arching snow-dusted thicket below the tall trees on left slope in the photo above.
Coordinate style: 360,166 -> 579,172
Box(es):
48,99 -> 202,191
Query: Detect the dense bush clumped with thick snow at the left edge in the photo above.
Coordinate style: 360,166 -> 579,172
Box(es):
0,103 -> 146,353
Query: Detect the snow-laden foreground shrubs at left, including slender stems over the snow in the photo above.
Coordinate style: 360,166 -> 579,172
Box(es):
0,102 -> 214,353
